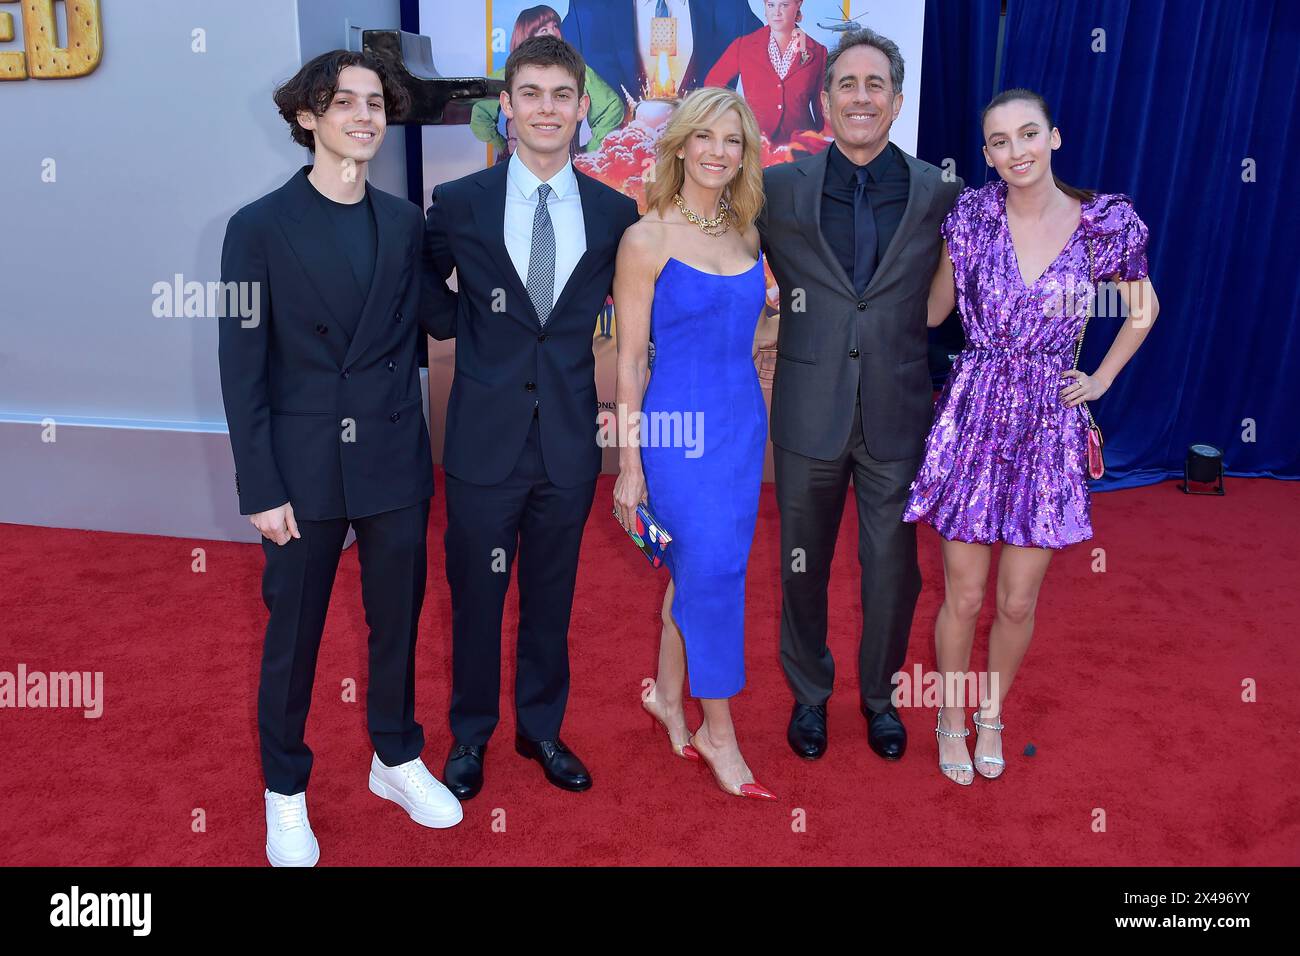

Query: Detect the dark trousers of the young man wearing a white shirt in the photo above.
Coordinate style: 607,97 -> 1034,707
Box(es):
443,418 -> 595,744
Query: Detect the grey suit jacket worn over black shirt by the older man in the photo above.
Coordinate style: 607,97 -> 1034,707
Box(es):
758,150 -> 963,460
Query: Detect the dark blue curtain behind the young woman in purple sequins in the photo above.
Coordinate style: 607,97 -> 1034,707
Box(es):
993,0 -> 1300,488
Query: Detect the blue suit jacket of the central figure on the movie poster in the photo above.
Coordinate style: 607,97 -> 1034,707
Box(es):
560,0 -> 763,99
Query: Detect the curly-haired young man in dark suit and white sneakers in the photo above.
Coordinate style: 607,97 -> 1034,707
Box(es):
220,49 -> 463,866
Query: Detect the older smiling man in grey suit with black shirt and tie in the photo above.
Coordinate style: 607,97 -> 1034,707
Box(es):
759,30 -> 962,760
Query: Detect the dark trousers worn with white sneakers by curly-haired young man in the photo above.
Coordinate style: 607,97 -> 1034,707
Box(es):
257,499 -> 429,793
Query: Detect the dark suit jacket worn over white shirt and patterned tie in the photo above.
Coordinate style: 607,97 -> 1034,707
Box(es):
420,159 -> 638,488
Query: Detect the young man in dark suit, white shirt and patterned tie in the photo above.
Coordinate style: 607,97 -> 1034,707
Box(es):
421,35 -> 637,800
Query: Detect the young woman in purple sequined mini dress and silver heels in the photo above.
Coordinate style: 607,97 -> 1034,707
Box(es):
904,90 -> 1158,786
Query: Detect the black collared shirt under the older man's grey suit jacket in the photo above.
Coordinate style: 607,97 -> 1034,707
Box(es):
822,143 -> 911,293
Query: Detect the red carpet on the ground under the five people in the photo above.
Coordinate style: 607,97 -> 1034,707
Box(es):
0,477 -> 1300,866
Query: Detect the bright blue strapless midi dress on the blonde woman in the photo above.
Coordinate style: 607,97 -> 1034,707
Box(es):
641,255 -> 767,698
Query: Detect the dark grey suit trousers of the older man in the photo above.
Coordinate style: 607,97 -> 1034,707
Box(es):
772,405 -> 920,711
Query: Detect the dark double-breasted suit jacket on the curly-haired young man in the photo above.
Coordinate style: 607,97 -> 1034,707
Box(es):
218,166 -> 433,520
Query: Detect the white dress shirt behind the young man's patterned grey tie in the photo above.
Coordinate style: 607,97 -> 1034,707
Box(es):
506,152 -> 586,304
